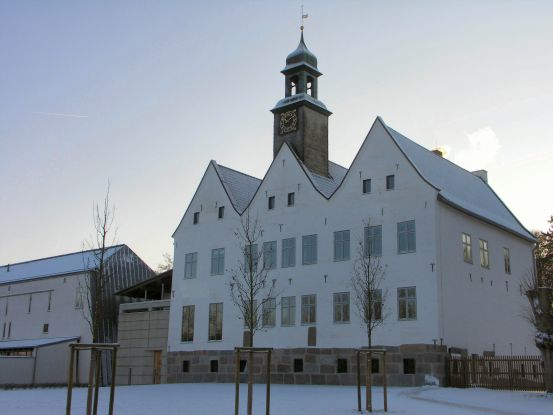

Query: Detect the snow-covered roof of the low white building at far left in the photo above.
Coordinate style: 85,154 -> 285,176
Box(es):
0,245 -> 124,284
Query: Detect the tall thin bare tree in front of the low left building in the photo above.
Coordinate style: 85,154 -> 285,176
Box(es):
82,182 -> 116,343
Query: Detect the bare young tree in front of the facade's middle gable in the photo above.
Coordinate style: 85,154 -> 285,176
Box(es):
229,211 -> 276,347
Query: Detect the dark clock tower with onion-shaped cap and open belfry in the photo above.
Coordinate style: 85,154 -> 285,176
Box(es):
271,30 -> 332,177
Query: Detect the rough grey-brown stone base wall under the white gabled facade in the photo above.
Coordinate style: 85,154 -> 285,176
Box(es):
167,344 -> 447,386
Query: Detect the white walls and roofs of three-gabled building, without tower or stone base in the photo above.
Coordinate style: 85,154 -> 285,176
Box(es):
168,118 -> 536,354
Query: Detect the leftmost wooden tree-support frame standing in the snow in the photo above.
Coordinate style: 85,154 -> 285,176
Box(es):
65,343 -> 119,415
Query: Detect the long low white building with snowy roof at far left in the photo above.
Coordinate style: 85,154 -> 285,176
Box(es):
0,245 -> 153,385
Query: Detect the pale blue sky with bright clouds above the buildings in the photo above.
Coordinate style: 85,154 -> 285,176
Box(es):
0,0 -> 553,267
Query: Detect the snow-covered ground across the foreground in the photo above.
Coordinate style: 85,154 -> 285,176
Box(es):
0,383 -> 553,415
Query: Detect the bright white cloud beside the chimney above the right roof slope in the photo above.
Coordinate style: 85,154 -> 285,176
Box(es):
453,127 -> 501,171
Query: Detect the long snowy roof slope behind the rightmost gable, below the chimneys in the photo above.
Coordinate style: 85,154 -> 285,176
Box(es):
382,121 -> 534,240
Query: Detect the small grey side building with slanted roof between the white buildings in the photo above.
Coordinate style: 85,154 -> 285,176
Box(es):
115,270 -> 173,385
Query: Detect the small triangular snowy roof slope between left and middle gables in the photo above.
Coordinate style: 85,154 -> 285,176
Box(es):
213,161 -> 261,214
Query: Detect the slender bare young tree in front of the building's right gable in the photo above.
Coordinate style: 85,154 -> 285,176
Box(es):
351,221 -> 388,348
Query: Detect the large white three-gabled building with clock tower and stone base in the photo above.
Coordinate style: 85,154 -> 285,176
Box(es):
168,35 -> 535,384
